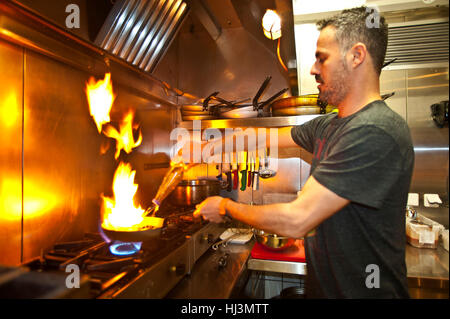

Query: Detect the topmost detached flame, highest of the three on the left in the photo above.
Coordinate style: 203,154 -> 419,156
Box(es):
86,73 -> 116,133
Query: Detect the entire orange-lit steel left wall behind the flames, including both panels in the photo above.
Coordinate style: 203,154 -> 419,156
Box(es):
0,1 -> 176,265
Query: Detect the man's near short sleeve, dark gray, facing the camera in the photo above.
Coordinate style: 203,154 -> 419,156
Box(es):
312,126 -> 403,208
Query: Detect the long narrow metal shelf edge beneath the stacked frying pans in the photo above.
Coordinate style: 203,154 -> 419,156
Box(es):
178,114 -> 321,130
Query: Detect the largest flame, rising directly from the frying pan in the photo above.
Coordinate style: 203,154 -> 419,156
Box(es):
102,162 -> 164,231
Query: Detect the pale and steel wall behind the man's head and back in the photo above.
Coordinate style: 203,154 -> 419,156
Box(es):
294,0 -> 449,227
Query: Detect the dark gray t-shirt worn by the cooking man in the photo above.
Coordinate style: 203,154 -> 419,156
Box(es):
291,101 -> 414,298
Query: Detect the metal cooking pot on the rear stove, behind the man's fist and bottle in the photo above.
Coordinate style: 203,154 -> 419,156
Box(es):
168,179 -> 222,206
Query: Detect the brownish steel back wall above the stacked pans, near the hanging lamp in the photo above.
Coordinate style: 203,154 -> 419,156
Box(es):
179,27 -> 289,101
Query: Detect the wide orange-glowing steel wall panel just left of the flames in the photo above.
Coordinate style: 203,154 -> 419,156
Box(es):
23,51 -> 110,261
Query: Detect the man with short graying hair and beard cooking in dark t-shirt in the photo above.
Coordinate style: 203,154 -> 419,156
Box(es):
195,7 -> 414,298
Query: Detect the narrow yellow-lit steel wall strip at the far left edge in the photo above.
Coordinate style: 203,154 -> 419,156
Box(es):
0,40 -> 23,266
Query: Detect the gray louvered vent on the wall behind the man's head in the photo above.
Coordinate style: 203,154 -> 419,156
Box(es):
385,20 -> 449,69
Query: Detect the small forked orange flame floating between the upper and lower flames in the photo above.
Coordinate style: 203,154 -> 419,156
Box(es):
103,110 -> 142,159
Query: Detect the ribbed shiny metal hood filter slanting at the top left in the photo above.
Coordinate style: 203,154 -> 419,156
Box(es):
95,0 -> 188,72
